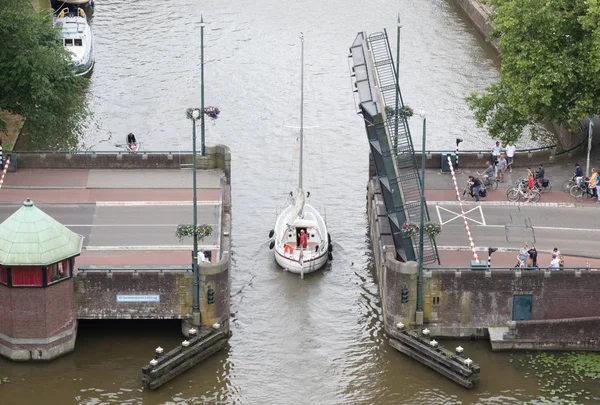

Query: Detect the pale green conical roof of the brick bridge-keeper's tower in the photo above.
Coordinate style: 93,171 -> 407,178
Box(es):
0,198 -> 83,266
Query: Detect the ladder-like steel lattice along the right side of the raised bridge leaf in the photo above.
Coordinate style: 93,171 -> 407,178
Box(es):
368,32 -> 439,263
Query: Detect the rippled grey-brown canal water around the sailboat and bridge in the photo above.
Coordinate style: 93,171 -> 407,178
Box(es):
0,0 -> 600,405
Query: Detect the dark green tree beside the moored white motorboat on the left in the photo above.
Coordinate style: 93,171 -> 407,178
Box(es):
0,0 -> 88,149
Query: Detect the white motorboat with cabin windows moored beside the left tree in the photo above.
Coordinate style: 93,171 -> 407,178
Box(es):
54,8 -> 94,76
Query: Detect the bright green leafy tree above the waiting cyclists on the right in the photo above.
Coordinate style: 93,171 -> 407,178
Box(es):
466,0 -> 600,142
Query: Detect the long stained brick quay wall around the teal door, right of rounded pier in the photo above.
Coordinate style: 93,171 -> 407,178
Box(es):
423,270 -> 600,338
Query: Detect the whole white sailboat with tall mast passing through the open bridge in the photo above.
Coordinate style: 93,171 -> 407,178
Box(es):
269,36 -> 333,277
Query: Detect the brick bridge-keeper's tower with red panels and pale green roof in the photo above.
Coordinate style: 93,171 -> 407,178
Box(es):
0,199 -> 83,360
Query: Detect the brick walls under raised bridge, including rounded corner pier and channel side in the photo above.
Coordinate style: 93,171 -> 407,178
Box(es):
367,179 -> 600,350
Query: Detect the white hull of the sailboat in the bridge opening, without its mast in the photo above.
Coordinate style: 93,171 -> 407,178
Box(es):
274,204 -> 329,274
